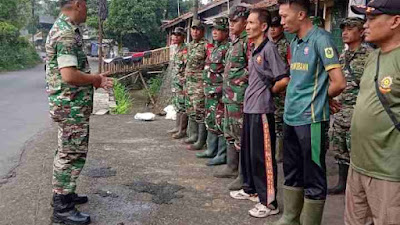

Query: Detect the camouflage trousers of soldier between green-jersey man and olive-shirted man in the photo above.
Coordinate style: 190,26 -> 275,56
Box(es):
330,121 -> 350,165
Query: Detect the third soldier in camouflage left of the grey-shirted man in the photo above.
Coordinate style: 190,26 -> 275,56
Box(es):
185,20 -> 213,150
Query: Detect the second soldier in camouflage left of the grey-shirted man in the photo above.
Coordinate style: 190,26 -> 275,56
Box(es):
196,17 -> 229,166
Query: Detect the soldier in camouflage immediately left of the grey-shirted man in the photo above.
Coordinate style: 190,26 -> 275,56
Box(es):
214,4 -> 250,190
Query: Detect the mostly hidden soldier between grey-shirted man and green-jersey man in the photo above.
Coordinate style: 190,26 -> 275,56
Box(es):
269,11 -> 290,163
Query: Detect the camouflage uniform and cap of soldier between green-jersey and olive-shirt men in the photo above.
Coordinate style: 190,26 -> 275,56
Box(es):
330,19 -> 372,165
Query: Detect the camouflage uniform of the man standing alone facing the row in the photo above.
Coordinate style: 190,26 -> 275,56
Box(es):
46,14 -> 93,194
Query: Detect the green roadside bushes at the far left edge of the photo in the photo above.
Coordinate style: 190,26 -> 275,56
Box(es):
0,37 -> 40,71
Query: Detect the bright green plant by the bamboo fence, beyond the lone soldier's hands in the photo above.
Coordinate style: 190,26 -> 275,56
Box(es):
112,79 -> 132,114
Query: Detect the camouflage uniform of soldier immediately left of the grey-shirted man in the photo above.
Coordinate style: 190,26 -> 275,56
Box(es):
222,31 -> 249,149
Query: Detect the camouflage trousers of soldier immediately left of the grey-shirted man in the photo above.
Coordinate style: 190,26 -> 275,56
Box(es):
223,104 -> 243,150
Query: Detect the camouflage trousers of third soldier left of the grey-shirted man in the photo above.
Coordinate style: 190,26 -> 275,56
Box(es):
185,73 -> 206,123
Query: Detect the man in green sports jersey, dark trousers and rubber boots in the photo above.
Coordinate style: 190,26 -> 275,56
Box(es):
276,0 -> 346,225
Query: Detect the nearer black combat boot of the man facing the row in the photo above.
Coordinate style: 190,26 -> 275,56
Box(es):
52,194 -> 90,225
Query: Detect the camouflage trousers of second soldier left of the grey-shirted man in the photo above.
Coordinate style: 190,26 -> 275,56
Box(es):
205,94 -> 224,135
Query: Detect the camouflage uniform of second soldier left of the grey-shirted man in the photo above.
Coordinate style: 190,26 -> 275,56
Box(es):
203,26 -> 229,134
